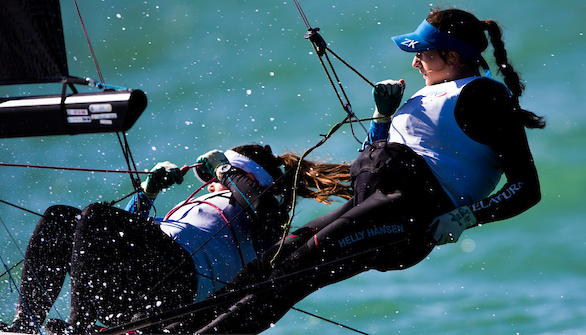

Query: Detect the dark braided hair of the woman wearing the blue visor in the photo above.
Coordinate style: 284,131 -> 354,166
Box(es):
427,8 -> 545,129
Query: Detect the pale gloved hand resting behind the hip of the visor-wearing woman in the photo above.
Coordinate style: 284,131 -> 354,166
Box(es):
428,206 -> 478,245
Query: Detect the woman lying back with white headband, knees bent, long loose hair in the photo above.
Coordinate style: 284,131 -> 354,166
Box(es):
3,145 -> 351,334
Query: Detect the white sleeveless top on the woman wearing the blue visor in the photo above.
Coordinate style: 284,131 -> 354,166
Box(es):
369,77 -> 502,206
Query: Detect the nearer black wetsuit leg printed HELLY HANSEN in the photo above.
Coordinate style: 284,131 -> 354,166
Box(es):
199,191 -> 433,334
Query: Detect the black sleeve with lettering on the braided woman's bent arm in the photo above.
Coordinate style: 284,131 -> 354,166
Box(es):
455,79 -> 541,224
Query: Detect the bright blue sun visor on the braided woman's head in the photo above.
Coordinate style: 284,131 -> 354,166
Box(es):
392,20 -> 480,60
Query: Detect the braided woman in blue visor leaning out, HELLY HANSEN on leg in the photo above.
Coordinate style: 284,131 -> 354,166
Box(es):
197,9 -> 545,334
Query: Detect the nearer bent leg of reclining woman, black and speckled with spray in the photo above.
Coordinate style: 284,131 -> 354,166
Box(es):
70,204 -> 198,333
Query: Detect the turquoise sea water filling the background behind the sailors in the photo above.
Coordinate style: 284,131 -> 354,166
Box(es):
0,0 -> 586,335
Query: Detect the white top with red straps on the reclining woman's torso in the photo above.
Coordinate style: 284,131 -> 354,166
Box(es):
158,191 -> 259,301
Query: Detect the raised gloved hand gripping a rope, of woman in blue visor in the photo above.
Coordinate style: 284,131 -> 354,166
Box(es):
372,79 -> 405,123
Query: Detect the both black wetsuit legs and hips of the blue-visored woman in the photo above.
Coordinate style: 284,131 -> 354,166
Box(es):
197,143 -> 454,333
